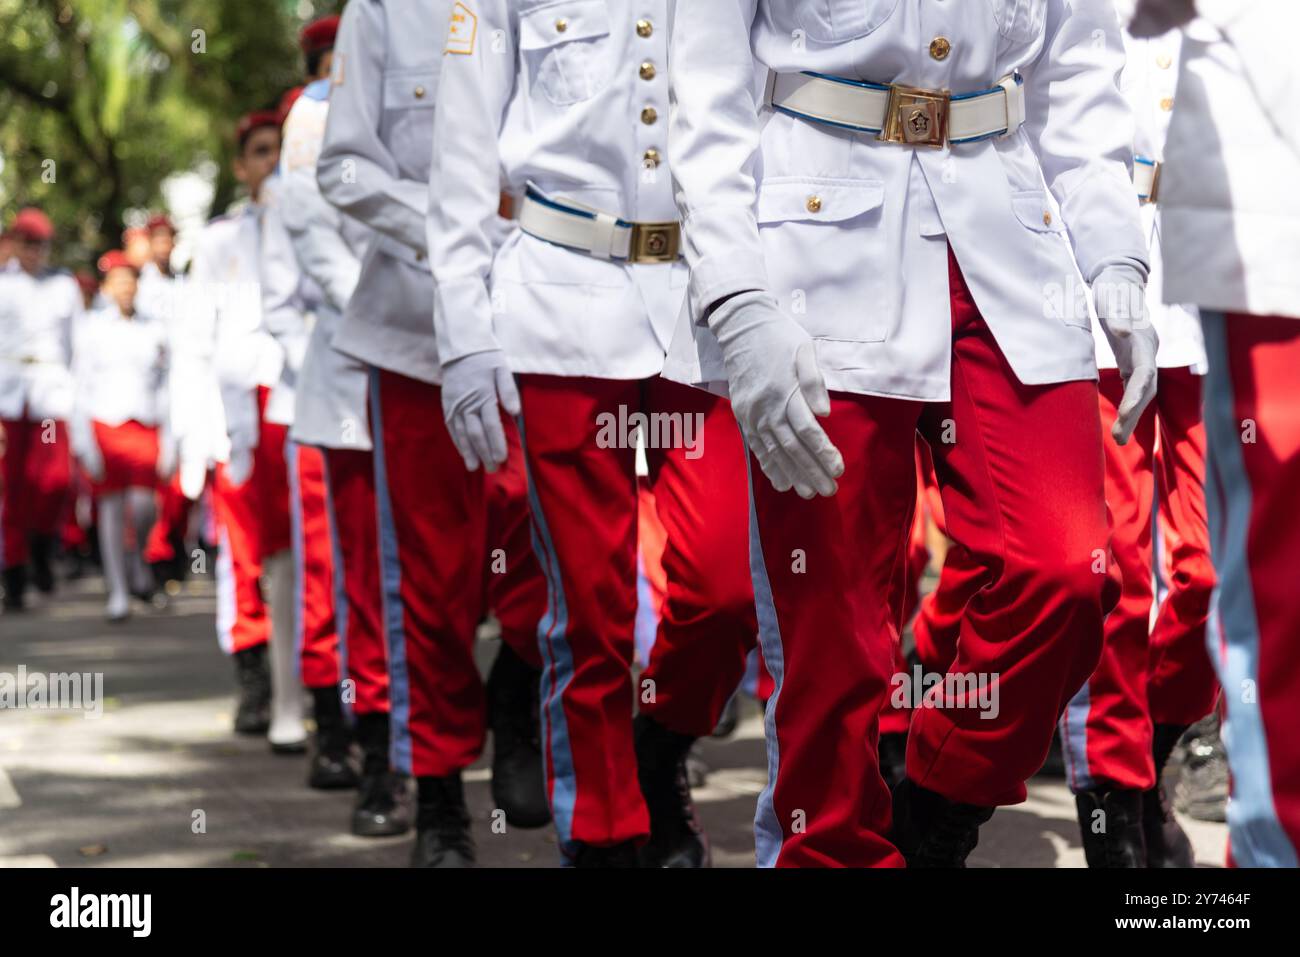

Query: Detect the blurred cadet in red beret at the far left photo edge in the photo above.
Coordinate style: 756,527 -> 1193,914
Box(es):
0,208 -> 82,611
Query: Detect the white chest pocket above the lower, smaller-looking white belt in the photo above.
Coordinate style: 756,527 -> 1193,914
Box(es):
519,0 -> 615,107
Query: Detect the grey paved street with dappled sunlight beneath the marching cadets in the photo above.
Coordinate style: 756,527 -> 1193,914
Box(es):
0,580 -> 1226,867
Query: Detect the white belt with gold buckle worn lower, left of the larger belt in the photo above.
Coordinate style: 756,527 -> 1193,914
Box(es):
519,186 -> 681,263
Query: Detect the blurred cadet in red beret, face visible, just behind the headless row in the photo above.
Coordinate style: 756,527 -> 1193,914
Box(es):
182,111 -> 296,752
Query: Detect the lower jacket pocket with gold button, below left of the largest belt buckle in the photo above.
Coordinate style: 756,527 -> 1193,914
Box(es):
758,177 -> 891,342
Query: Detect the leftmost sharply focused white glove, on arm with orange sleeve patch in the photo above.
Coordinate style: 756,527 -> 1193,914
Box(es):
442,348 -> 520,472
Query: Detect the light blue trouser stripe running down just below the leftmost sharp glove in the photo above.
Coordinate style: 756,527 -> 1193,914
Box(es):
516,416 -> 577,853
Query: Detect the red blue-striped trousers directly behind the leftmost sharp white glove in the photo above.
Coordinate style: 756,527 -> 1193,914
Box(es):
371,369 -> 542,776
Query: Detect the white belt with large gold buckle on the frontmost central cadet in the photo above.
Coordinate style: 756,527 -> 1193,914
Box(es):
766,73 -> 1024,147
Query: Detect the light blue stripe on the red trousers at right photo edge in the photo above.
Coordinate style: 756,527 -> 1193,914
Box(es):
1201,309 -> 1296,867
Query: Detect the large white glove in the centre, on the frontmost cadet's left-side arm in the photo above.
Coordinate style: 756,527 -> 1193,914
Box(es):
709,293 -> 844,498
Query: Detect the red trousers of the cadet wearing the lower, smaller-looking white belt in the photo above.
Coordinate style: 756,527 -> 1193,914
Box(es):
519,376 -> 755,848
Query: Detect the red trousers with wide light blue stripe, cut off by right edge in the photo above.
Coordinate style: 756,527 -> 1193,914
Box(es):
1201,312 -> 1300,867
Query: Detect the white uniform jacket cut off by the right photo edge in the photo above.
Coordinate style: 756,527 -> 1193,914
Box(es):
1160,0 -> 1300,317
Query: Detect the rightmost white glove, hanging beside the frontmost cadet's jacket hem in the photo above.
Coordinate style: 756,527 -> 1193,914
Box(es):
1092,265 -> 1160,445
